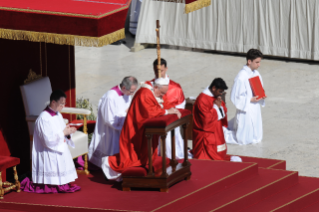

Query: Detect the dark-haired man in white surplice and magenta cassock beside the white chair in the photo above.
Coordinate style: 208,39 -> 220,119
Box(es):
21,90 -> 80,193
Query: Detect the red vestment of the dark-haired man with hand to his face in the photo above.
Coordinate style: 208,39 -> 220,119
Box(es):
193,93 -> 230,161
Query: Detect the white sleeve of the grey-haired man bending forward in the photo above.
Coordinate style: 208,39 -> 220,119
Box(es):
101,97 -> 126,130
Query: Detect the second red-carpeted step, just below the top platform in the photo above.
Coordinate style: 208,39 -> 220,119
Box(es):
176,168 -> 298,212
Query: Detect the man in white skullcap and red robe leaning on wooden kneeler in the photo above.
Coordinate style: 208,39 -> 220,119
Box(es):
102,78 -> 181,181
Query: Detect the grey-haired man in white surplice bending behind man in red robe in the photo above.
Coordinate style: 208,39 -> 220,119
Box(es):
88,76 -> 138,167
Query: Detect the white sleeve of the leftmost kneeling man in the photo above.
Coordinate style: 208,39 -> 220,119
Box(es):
35,119 -> 66,153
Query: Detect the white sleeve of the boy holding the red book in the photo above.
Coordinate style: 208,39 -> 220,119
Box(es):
230,79 -> 250,112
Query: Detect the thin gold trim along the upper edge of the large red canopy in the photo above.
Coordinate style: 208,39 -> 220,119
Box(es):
0,4 -> 130,18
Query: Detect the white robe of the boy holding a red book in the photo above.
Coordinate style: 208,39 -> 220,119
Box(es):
224,65 -> 265,145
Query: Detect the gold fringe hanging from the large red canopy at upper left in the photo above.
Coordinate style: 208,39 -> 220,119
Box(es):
0,28 -> 125,47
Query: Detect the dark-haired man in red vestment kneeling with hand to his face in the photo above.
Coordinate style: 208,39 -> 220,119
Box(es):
192,78 -> 241,161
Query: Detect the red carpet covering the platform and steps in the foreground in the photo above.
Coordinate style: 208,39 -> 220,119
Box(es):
0,157 -> 319,212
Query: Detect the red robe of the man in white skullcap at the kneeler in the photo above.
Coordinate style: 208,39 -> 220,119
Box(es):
109,85 -> 172,173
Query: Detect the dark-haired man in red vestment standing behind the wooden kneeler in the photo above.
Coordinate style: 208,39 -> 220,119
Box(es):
152,58 -> 186,159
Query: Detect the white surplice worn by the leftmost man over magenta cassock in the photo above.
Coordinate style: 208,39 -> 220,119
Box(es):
32,111 -> 78,185
